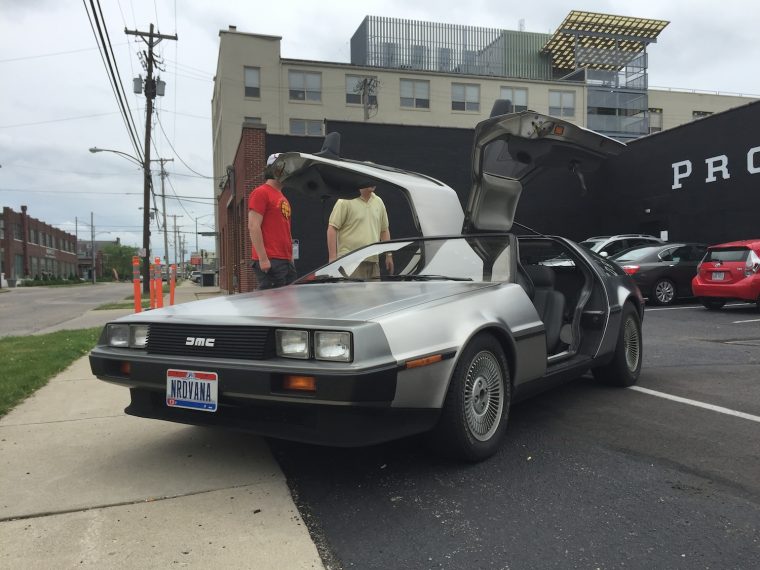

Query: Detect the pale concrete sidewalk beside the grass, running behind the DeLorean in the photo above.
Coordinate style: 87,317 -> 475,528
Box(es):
0,282 -> 323,570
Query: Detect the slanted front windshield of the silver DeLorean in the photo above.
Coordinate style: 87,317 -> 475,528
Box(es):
297,234 -> 513,284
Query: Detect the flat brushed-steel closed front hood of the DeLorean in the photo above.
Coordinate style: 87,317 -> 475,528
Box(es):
113,281 -> 494,326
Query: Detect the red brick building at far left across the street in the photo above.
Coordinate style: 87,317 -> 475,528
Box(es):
0,206 -> 77,282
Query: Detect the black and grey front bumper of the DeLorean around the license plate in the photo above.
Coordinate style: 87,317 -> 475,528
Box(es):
90,347 -> 440,447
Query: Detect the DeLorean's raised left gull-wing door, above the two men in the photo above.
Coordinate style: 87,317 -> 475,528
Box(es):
273,152 -> 464,236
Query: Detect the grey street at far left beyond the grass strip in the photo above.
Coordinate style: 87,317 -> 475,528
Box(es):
0,283 -> 133,337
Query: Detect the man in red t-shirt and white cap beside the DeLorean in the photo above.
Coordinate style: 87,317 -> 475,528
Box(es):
248,154 -> 297,289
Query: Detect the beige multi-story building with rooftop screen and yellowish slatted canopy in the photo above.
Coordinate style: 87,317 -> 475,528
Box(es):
212,11 -> 757,184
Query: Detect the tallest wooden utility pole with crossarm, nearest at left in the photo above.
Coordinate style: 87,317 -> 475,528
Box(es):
124,24 -> 178,294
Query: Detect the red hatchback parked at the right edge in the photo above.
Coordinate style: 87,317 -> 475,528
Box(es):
691,239 -> 760,310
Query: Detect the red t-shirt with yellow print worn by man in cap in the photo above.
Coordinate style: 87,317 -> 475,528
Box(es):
248,184 -> 293,260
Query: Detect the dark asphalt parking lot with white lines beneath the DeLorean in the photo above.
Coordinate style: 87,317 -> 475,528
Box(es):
271,304 -> 760,569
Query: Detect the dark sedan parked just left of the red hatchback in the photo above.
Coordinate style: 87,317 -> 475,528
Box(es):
609,243 -> 707,305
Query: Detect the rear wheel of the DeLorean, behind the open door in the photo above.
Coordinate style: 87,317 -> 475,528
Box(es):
592,303 -> 644,388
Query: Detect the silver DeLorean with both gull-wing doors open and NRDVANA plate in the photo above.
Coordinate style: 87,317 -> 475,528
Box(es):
90,111 -> 644,461
